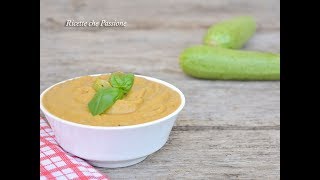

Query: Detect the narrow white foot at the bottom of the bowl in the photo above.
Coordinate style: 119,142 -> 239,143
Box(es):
87,156 -> 147,168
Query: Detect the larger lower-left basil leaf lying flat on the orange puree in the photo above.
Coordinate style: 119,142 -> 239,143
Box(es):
88,88 -> 124,116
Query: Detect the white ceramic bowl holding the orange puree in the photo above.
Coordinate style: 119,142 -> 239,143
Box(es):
40,74 -> 185,168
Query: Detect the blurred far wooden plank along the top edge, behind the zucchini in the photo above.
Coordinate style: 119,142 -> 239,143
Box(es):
40,0 -> 280,31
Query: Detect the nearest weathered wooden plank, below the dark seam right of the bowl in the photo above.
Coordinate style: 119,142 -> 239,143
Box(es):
98,130 -> 280,179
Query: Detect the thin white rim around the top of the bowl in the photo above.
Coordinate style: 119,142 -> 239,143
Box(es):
40,73 -> 186,130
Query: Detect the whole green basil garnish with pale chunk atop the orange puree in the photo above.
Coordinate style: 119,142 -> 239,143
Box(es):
88,72 -> 134,116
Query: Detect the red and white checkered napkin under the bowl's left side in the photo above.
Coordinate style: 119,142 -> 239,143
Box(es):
40,117 -> 109,180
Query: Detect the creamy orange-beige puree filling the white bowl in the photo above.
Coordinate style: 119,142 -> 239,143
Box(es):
43,75 -> 181,126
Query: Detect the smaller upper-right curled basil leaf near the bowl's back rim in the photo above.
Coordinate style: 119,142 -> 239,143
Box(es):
109,72 -> 134,94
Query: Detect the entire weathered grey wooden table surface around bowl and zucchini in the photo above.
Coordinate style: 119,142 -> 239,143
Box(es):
40,0 -> 280,179
